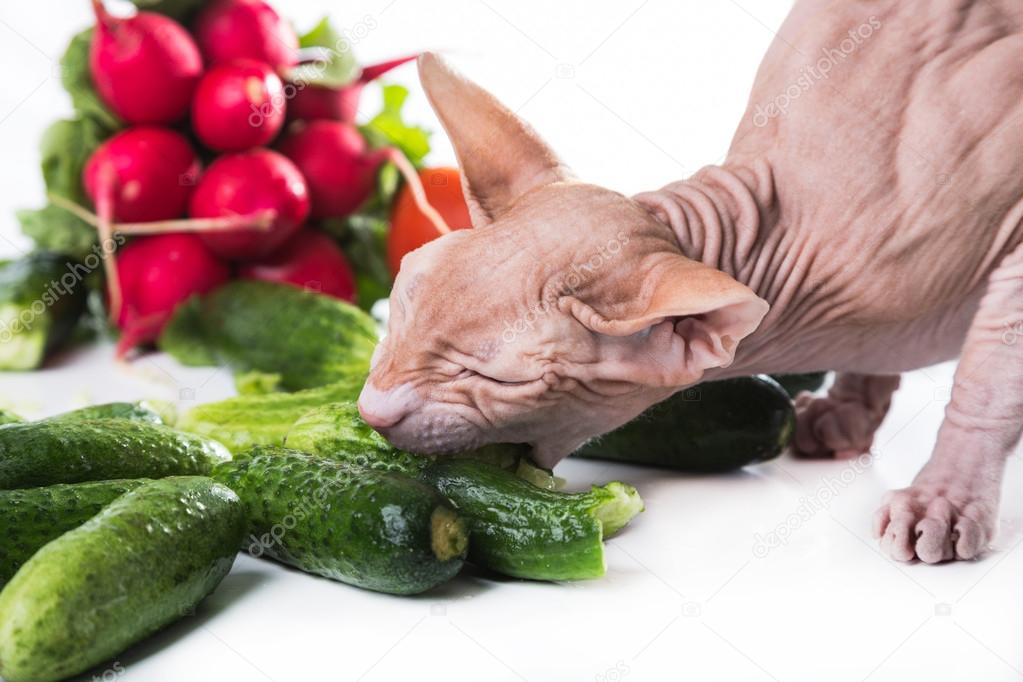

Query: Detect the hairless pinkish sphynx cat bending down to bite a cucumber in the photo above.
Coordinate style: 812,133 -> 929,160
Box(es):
359,0 -> 1023,563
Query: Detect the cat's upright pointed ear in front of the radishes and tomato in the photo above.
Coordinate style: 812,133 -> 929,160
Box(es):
418,52 -> 572,227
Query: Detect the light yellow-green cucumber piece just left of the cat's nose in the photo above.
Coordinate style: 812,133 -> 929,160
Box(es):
175,376 -> 365,452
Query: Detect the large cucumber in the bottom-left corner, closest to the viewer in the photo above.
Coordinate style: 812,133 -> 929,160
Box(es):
0,476 -> 246,682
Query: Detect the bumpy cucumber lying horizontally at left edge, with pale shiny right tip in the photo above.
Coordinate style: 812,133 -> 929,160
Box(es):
0,419 -> 231,490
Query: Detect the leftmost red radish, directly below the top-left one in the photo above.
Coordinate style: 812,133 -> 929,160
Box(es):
82,126 -> 199,222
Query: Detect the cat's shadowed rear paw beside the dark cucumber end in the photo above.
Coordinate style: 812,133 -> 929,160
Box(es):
792,393 -> 885,459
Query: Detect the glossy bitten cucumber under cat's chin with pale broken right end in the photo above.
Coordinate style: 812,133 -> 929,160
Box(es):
421,459 -> 643,580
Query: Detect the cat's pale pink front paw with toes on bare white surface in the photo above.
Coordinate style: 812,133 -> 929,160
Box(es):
874,484 -> 997,563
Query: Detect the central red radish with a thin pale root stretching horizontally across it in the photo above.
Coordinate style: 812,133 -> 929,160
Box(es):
188,149 -> 309,260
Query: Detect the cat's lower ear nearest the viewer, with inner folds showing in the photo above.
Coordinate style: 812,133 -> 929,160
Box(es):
562,255 -> 769,387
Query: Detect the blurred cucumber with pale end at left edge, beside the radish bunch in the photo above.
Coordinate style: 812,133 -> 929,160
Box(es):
0,252 -> 89,370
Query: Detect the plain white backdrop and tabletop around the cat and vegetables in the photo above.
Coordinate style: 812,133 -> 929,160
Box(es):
0,0 -> 1023,682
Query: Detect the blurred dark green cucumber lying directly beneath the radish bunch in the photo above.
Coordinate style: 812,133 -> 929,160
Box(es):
161,279 -> 376,391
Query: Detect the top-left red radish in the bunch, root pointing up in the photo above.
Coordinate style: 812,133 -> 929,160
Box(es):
89,0 -> 203,124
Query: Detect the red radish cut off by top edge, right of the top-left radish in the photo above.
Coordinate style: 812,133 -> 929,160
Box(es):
193,0 -> 299,72
